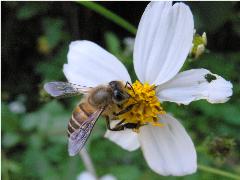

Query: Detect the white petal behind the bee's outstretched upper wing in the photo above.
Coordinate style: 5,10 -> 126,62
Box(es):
63,41 -> 131,87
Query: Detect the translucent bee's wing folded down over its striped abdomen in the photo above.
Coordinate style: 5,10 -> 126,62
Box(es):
68,108 -> 105,156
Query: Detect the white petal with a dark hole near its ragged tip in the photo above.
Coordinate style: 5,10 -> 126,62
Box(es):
157,69 -> 232,104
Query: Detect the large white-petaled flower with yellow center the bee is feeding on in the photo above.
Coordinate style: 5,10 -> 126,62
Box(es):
64,2 -> 232,176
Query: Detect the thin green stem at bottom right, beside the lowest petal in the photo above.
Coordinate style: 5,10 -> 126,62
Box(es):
198,164 -> 240,179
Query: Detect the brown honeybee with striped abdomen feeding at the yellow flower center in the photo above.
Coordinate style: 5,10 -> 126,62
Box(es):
44,81 -> 138,156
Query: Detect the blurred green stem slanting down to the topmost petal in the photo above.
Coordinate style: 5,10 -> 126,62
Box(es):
77,1 -> 137,35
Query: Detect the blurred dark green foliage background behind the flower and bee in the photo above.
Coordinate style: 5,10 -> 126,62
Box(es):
1,2 -> 240,180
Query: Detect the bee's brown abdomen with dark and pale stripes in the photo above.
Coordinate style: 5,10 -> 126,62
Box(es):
67,103 -> 92,137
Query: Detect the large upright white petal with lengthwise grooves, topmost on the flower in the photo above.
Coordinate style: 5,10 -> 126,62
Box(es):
134,2 -> 194,85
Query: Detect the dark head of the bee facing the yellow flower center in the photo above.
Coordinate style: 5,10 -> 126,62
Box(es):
109,81 -> 130,104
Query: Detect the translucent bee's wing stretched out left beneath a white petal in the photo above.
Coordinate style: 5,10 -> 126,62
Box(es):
44,81 -> 91,98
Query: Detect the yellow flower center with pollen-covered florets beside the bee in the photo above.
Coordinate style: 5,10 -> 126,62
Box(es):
118,81 -> 165,126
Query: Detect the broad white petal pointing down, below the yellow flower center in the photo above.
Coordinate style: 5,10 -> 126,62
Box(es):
139,115 -> 197,176
